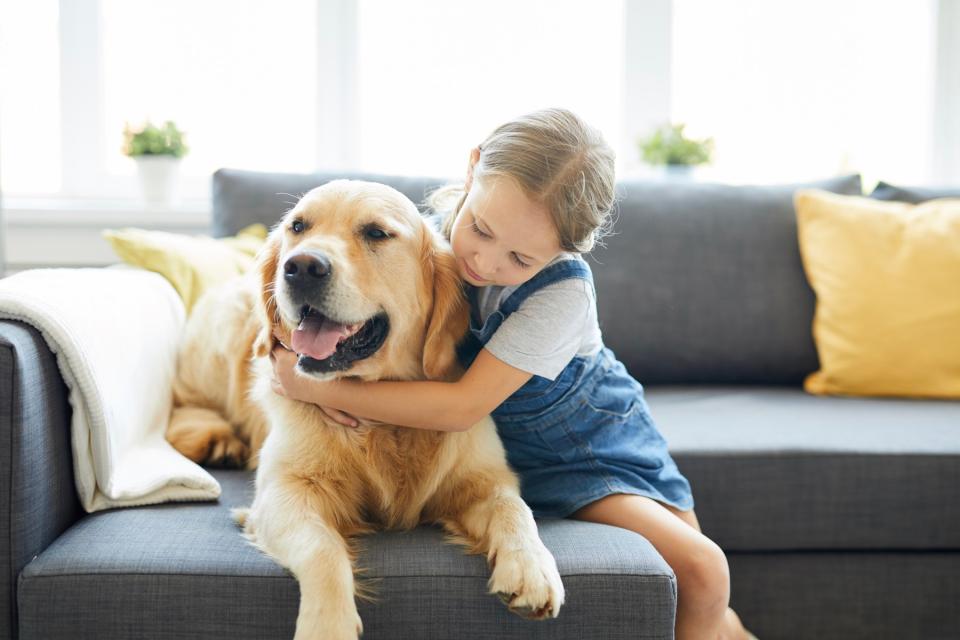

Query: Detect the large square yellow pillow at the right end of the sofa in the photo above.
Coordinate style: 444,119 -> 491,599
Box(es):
795,189 -> 960,398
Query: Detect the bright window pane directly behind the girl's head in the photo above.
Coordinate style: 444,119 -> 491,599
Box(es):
357,0 -> 624,176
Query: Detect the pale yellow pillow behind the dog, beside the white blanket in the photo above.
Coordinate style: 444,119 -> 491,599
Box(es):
103,224 -> 267,314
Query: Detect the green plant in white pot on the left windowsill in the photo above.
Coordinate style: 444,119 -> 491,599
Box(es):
123,120 -> 188,205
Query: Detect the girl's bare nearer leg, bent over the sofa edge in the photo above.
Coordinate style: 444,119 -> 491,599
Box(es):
572,494 -> 747,640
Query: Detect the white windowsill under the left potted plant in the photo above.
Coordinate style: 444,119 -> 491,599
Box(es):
2,198 -> 210,231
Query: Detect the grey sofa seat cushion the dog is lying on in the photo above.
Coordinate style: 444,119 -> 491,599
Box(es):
18,471 -> 676,639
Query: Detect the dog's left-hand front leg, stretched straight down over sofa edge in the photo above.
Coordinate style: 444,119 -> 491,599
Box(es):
244,490 -> 363,640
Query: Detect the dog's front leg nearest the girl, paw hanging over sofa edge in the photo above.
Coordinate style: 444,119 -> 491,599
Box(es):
445,476 -> 564,619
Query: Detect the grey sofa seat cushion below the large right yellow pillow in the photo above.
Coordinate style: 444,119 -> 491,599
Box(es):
646,386 -> 960,551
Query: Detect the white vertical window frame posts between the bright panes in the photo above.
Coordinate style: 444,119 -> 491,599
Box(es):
26,0 -> 960,201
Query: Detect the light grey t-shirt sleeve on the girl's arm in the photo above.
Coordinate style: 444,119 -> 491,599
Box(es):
484,278 -> 593,380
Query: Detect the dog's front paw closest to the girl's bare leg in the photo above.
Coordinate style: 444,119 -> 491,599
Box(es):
489,544 -> 564,620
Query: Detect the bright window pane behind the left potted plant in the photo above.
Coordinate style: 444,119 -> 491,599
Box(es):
100,0 -> 318,179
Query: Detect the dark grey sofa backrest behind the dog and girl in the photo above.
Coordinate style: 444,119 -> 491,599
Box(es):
212,169 -> 861,385
